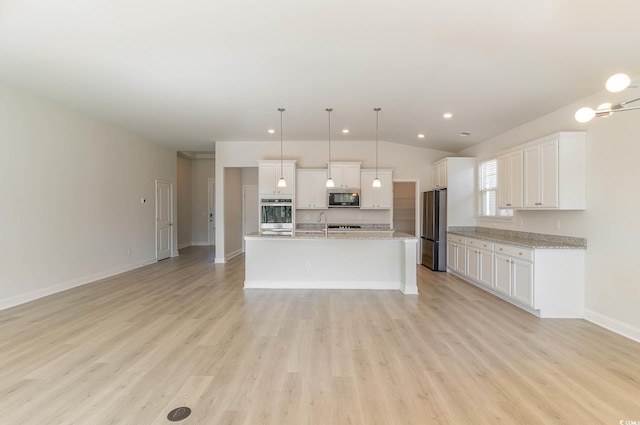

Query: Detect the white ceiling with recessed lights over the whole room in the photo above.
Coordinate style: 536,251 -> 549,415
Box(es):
0,0 -> 640,152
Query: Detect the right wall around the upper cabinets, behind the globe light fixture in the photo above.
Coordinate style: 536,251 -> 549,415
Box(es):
461,91 -> 640,340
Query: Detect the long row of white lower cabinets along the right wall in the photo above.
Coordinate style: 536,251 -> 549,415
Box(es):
447,234 -> 585,318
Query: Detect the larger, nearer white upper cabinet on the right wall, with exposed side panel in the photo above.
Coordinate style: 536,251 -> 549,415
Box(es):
523,131 -> 586,210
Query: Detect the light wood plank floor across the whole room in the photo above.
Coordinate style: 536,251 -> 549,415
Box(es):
0,247 -> 640,425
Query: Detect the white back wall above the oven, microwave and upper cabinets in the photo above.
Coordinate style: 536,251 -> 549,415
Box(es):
216,141 -> 451,263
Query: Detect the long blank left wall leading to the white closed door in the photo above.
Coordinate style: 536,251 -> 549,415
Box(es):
0,84 -> 177,308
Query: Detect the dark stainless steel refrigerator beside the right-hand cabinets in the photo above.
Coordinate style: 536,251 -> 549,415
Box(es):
420,189 -> 447,271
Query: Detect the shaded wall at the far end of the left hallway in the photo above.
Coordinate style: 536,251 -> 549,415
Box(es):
191,159 -> 215,245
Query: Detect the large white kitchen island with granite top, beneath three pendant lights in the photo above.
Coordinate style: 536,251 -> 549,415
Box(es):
244,231 -> 418,294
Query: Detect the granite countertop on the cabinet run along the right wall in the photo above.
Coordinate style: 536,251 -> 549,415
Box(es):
447,227 -> 587,249
